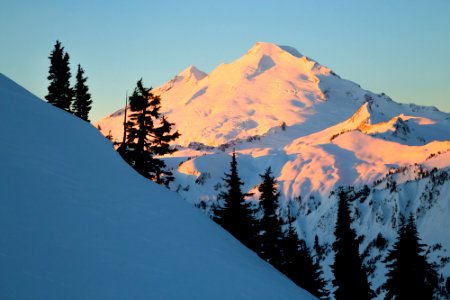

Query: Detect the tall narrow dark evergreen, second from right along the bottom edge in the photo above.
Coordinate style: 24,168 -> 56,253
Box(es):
331,190 -> 373,300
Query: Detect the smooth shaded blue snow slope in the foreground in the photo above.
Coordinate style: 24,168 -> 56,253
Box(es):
0,74 -> 314,299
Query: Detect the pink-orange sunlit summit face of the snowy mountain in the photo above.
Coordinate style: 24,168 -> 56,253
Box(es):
100,42 -> 342,146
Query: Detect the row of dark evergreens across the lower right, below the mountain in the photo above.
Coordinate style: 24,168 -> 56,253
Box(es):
213,152 -> 442,300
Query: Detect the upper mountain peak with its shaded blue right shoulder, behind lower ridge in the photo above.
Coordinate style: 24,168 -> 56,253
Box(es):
98,43 -> 449,146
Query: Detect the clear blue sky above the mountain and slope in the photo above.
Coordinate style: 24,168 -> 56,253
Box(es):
0,0 -> 450,120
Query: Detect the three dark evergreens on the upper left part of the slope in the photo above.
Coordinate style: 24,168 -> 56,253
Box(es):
45,41 -> 180,186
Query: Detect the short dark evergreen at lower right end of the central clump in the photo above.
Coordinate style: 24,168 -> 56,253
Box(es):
279,222 -> 328,299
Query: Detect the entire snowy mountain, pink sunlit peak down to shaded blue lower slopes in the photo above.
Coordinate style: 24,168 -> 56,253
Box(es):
98,43 -> 450,299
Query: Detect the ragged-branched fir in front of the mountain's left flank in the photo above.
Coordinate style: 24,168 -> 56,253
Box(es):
121,79 -> 180,186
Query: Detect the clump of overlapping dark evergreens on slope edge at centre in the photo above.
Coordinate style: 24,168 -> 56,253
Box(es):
213,152 -> 328,299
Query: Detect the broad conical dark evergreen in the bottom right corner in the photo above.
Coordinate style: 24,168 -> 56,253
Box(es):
383,215 -> 438,300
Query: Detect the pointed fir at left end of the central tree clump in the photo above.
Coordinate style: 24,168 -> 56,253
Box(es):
214,151 -> 255,249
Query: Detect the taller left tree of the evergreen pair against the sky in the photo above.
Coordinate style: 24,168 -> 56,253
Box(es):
45,41 -> 72,111
